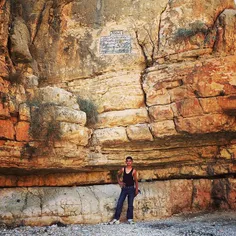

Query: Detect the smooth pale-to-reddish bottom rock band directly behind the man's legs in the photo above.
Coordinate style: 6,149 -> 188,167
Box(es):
0,178 -> 236,225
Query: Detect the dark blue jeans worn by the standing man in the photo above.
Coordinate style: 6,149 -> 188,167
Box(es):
114,186 -> 135,220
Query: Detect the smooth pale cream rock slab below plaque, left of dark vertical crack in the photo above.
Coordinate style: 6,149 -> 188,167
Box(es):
67,70 -> 145,113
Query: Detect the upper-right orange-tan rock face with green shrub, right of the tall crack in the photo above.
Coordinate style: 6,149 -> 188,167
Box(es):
158,0 -> 235,58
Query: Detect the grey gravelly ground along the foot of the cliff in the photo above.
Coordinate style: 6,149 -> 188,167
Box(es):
0,211 -> 236,236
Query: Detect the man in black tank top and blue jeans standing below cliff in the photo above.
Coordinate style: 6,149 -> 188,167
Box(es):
109,156 -> 139,224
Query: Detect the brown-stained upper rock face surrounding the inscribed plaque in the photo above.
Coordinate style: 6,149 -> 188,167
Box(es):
21,0 -> 168,81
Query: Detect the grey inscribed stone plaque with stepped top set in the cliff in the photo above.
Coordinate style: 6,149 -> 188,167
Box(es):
100,30 -> 131,54
